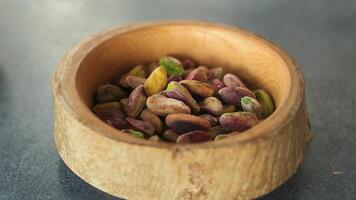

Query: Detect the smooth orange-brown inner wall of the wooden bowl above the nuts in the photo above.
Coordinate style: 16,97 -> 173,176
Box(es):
75,23 -> 291,145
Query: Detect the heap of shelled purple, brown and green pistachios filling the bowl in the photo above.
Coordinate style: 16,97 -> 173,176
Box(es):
93,56 -> 274,143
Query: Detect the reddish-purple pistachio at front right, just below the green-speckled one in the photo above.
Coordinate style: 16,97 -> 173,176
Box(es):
219,112 -> 258,132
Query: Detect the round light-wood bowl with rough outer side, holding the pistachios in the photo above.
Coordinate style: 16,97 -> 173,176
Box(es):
53,21 -> 311,200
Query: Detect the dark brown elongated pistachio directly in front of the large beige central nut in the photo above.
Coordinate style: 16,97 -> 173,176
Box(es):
166,114 -> 210,134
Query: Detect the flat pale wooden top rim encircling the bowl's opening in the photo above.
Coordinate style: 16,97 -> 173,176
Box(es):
52,20 -> 304,149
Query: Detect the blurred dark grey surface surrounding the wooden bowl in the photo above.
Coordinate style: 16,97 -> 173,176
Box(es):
0,0 -> 356,200
